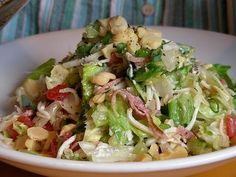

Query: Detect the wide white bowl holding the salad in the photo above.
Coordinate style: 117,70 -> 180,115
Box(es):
0,27 -> 236,177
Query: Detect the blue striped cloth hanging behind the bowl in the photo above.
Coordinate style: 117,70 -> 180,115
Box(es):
0,0 -> 236,43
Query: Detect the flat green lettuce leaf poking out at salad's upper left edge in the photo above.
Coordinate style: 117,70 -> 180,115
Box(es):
27,58 -> 56,80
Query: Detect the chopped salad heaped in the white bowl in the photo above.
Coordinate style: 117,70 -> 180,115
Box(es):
0,16 -> 236,162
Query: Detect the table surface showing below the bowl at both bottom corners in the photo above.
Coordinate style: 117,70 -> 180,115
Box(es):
0,158 -> 236,177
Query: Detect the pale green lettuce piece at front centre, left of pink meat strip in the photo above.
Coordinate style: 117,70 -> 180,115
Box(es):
91,97 -> 133,145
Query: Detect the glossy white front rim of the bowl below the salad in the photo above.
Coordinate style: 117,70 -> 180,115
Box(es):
0,147 -> 236,173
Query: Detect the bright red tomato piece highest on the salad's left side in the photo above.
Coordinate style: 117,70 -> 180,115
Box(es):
46,84 -> 69,101
